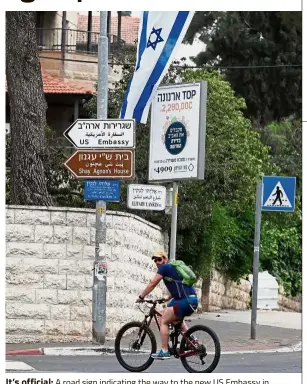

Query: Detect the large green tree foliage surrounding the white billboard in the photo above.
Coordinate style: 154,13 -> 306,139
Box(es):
83,63 -> 268,278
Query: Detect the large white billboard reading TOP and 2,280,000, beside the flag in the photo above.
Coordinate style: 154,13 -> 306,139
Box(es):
149,81 -> 207,181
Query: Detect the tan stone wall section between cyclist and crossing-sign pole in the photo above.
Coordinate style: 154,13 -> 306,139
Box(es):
202,270 -> 251,312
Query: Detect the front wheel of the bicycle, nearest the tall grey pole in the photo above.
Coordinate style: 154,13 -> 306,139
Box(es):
115,321 -> 157,372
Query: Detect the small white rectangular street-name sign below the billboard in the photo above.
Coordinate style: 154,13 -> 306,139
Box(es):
127,184 -> 166,211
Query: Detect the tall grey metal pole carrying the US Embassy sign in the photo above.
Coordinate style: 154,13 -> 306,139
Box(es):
92,11 -> 108,344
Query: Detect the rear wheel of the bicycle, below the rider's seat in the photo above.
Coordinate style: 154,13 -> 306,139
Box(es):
179,325 -> 221,373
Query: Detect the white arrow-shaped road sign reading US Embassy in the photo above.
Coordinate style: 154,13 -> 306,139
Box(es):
64,119 -> 135,149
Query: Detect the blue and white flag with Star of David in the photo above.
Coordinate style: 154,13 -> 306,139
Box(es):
120,11 -> 195,124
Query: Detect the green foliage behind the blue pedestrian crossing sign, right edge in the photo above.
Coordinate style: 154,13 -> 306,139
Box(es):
260,118 -> 302,296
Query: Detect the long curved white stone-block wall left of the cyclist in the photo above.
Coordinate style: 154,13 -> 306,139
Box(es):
6,206 -> 168,343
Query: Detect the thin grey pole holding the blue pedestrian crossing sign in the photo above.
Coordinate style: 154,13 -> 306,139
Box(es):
251,183 -> 262,339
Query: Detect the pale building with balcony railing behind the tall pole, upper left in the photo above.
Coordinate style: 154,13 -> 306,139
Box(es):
36,11 -> 139,91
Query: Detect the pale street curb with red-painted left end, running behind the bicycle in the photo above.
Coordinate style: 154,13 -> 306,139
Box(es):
6,342 -> 302,356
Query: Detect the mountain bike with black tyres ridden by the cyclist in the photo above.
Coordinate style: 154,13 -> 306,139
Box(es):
115,299 -> 221,373
